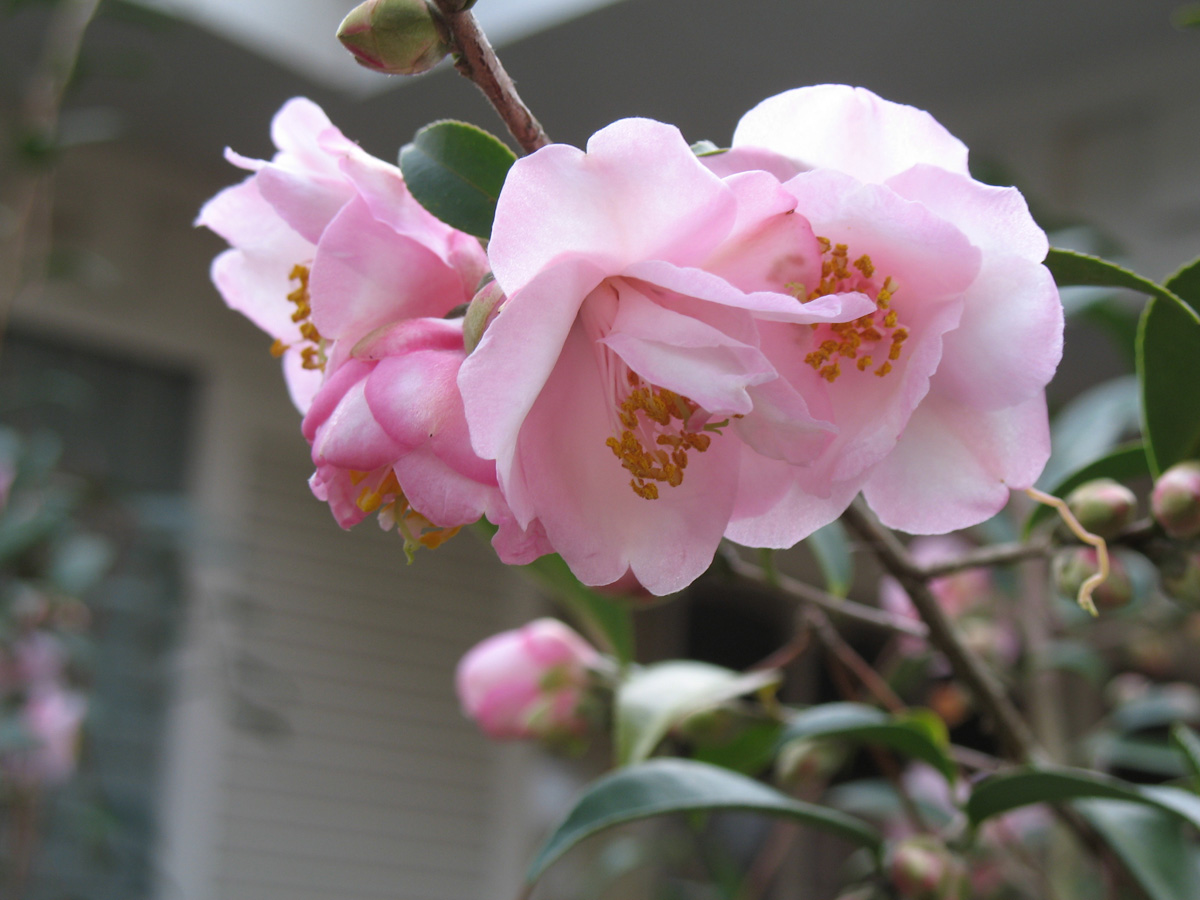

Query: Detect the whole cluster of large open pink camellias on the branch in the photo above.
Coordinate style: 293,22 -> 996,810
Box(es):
198,85 -> 1062,594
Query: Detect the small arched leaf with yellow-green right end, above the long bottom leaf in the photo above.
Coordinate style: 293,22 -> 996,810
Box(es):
780,703 -> 958,781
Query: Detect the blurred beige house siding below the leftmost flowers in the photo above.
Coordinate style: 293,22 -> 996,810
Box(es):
208,439 -> 528,900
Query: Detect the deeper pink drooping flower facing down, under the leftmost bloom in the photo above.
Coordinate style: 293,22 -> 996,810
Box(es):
304,319 -> 550,564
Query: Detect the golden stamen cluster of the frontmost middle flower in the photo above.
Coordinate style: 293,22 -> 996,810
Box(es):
605,372 -> 713,500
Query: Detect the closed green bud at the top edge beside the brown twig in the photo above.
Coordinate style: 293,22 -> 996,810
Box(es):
337,0 -> 450,74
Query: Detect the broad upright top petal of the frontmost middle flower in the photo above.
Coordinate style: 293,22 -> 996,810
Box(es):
488,119 -> 737,294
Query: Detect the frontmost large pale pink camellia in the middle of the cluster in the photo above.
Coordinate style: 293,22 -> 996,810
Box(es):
458,119 -> 876,594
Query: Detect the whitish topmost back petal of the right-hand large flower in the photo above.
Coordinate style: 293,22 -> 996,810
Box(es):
733,84 -> 967,182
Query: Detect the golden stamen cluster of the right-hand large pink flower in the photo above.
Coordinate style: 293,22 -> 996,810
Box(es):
787,238 -> 908,384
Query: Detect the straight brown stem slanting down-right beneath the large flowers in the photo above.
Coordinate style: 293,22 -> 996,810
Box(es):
844,504 -> 1037,762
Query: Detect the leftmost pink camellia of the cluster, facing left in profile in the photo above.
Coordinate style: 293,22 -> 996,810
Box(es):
196,97 -> 487,412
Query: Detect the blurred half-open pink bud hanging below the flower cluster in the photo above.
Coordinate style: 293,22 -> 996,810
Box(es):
455,619 -> 601,739
